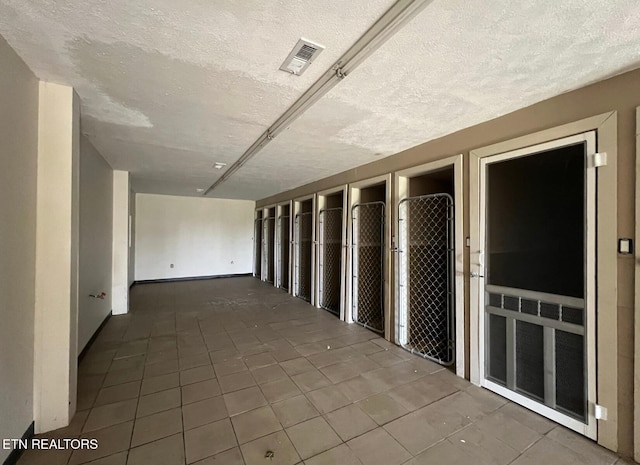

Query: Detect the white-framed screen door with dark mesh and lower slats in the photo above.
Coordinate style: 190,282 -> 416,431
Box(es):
472,132 -> 597,438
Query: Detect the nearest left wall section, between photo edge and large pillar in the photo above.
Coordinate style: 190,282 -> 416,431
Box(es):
0,37 -> 38,463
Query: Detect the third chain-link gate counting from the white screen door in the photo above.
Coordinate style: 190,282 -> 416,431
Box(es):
318,208 -> 342,315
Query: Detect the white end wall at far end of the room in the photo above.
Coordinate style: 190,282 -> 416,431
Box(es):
135,194 -> 255,281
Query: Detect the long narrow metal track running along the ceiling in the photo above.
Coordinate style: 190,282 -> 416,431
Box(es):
204,0 -> 433,195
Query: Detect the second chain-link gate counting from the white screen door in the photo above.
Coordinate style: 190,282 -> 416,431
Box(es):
351,202 -> 385,333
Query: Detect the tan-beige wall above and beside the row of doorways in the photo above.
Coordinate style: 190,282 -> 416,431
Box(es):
257,70 -> 640,455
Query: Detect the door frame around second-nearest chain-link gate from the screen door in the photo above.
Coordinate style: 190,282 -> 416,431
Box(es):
345,173 -> 393,341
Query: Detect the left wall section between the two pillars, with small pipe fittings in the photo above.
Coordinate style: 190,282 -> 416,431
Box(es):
78,137 -> 113,353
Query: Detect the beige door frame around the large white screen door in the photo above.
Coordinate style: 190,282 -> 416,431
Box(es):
469,112 -> 618,451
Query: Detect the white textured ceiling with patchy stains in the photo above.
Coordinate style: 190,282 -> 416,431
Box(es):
0,0 -> 640,199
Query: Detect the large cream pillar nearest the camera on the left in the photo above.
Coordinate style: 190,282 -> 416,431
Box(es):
33,81 -> 80,433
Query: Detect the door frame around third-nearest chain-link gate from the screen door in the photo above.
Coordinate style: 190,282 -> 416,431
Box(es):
313,184 -> 348,321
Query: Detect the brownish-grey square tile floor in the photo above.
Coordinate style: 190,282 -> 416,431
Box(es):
19,278 -> 631,465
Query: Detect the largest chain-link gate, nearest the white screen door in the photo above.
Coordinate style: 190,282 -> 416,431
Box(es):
398,194 -> 455,365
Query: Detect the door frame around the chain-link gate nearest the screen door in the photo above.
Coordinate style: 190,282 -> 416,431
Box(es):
392,154 -> 467,378
